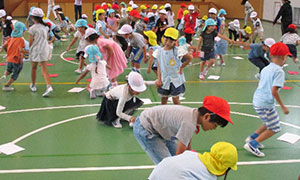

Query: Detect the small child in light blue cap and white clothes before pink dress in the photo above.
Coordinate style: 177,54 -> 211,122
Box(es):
76,45 -> 110,99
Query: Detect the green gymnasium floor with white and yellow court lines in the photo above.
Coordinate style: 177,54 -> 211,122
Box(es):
0,22 -> 300,180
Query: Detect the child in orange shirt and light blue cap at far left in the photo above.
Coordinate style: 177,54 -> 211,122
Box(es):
1,22 -> 26,91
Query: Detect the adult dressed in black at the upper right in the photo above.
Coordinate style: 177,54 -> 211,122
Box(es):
273,0 -> 293,35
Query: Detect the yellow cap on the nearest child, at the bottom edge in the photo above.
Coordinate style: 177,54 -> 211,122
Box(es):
198,142 -> 238,176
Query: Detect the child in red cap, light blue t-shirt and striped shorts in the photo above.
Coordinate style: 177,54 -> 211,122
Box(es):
244,42 -> 291,157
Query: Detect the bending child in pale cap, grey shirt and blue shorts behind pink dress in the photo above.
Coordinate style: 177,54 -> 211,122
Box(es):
118,24 -> 147,73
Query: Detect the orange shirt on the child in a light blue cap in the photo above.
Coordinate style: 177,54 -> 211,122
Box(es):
6,37 -> 25,64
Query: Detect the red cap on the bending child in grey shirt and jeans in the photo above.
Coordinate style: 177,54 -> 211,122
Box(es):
203,96 -> 233,124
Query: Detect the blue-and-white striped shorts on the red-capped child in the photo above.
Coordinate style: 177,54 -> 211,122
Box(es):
254,106 -> 281,133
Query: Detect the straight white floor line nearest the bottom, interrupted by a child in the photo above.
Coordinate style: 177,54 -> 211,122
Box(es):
0,159 -> 300,174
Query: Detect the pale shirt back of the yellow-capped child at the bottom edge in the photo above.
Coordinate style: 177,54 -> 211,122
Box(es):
149,151 -> 217,180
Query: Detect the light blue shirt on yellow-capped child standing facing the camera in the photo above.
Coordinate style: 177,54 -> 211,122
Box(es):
157,47 -> 185,90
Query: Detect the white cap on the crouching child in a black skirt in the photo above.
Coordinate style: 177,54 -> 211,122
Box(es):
128,72 -> 147,92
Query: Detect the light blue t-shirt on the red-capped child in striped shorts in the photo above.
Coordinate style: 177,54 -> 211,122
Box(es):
253,63 -> 285,108
